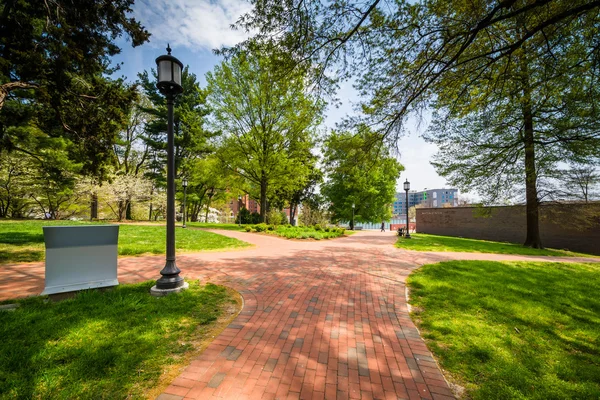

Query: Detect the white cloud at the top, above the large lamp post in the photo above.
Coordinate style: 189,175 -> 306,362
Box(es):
133,0 -> 251,50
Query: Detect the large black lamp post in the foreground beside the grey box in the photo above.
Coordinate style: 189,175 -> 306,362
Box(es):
150,46 -> 188,296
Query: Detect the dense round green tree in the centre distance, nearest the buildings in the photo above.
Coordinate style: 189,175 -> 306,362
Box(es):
321,126 -> 404,227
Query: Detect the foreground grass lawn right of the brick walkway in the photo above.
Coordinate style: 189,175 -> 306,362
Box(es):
408,261 -> 600,400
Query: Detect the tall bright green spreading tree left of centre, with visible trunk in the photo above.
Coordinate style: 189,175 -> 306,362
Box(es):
207,53 -> 323,221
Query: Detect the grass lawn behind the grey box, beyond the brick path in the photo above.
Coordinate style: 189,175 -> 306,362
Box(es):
0,221 -> 249,263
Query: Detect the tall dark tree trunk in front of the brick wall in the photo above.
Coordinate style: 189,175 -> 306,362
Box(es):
519,49 -> 542,249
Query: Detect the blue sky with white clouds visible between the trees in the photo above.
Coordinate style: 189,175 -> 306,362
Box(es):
113,0 -> 458,191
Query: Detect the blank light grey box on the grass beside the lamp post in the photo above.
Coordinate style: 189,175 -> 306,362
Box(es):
42,225 -> 119,295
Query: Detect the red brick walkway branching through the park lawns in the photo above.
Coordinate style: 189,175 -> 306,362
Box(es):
0,231 -> 593,400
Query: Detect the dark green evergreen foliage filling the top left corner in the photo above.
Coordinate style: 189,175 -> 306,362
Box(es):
0,0 -> 150,174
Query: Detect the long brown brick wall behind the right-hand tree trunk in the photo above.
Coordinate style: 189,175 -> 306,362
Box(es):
417,203 -> 600,255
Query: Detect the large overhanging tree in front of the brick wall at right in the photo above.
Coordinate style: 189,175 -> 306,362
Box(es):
235,0 -> 600,247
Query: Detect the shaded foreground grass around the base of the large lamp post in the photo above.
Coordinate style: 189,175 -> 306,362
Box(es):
0,281 -> 240,399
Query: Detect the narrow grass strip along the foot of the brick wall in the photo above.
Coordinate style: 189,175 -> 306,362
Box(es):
396,233 -> 593,257
